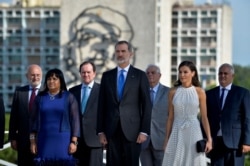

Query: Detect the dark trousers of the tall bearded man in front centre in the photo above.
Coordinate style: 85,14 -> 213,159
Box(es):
107,123 -> 141,166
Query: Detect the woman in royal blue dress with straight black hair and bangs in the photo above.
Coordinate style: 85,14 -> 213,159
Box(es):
30,69 -> 80,166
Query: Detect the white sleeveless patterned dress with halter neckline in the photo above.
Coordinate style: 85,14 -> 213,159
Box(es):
162,86 -> 207,166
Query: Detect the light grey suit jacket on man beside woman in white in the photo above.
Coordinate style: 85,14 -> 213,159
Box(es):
142,84 -> 169,150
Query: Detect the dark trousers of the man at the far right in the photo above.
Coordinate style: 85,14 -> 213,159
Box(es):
209,137 -> 244,166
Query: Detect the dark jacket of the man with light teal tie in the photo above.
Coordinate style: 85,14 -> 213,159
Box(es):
69,82 -> 101,147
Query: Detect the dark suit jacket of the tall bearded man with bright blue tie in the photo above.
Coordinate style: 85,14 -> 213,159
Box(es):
97,66 -> 152,141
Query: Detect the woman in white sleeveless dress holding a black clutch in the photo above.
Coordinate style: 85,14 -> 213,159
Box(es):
162,61 -> 212,166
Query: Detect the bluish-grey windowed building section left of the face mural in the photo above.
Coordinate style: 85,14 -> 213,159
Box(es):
0,5 -> 60,111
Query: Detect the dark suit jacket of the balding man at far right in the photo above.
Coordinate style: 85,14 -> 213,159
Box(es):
206,85 -> 250,149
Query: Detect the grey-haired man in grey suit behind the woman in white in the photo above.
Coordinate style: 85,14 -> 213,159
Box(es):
140,64 -> 169,166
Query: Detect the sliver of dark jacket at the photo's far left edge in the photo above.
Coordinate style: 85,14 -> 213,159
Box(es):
0,98 -> 5,148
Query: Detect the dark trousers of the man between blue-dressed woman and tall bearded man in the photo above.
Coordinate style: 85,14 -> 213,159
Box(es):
74,139 -> 103,166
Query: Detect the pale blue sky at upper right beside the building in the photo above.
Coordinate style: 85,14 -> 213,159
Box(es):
0,0 -> 250,66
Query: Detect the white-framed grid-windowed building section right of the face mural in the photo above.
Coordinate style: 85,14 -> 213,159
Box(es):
171,4 -> 232,88
